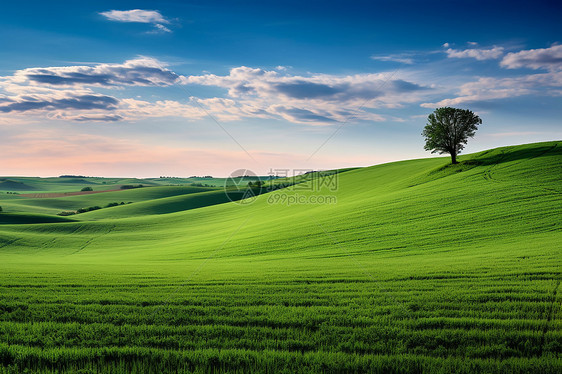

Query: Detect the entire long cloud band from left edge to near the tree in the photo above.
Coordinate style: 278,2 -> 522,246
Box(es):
0,57 -> 430,125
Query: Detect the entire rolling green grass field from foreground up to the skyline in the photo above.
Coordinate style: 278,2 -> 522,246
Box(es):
0,141 -> 562,373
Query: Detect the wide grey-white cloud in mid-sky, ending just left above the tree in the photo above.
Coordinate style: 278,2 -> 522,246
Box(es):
181,66 -> 429,124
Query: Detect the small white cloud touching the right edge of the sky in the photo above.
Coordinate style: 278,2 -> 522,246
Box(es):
500,45 -> 562,70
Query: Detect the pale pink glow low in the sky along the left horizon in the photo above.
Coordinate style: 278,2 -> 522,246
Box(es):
0,134 -> 388,177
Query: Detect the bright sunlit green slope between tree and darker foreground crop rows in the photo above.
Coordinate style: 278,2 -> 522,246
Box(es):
0,142 -> 562,263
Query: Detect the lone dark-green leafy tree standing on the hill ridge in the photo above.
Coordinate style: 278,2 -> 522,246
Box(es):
422,107 -> 482,164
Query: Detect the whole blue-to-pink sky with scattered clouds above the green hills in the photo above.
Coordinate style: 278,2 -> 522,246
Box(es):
0,0 -> 562,177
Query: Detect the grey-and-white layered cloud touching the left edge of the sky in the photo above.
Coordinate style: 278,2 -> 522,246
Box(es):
0,57 -> 189,121
